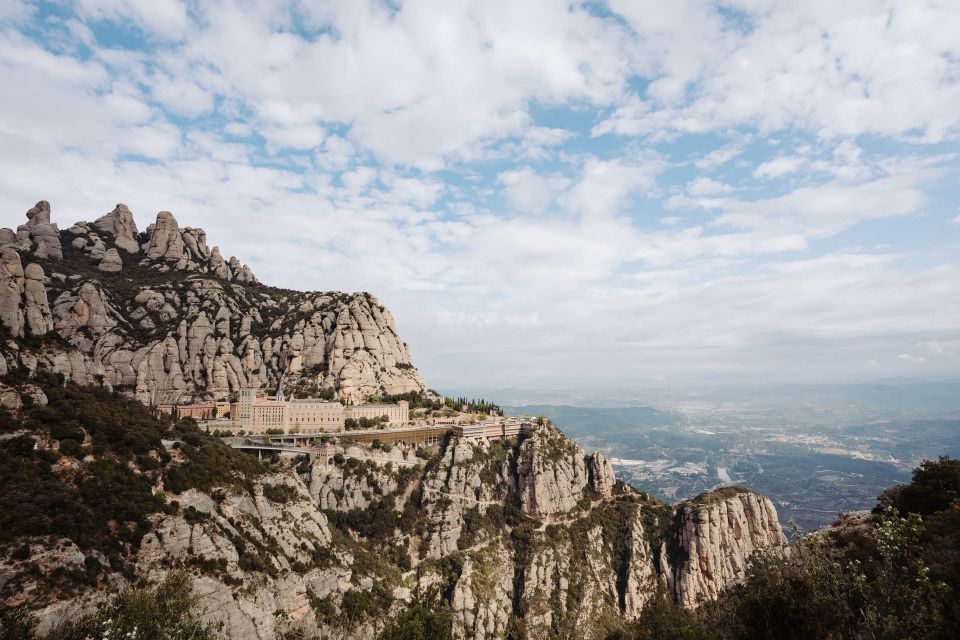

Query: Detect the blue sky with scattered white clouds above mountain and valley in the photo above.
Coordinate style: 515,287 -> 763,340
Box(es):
0,0 -> 960,388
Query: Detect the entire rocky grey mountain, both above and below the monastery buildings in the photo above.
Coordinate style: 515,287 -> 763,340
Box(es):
0,202 -> 787,639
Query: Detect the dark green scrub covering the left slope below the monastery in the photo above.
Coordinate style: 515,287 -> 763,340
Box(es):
0,371 -> 265,596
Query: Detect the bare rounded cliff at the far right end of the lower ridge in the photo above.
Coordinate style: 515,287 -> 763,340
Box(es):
663,489 -> 787,607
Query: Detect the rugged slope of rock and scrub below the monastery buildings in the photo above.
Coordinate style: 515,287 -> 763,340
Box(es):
0,369 -> 785,638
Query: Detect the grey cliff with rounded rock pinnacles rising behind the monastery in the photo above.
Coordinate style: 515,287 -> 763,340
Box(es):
0,201 -> 424,403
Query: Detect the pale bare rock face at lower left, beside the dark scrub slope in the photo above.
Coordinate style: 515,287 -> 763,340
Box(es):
136,474 -> 351,638
